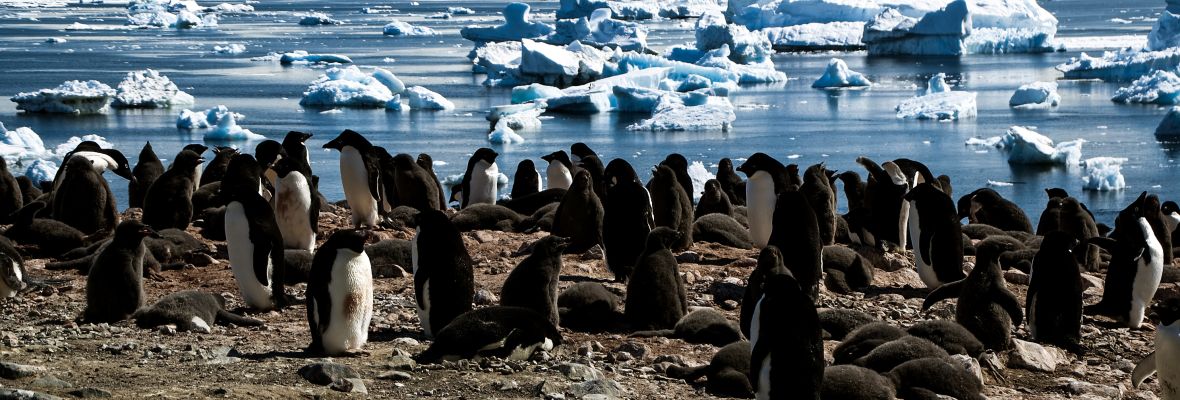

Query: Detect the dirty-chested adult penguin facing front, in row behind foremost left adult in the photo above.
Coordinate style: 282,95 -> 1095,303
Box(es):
274,157 -> 320,251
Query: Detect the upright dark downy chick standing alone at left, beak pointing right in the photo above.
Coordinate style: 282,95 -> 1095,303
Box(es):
83,219 -> 159,323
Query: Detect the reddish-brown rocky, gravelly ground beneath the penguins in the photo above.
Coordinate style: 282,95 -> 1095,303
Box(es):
0,206 -> 1180,399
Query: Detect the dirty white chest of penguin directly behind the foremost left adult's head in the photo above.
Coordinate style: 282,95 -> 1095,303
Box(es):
275,172 -> 315,250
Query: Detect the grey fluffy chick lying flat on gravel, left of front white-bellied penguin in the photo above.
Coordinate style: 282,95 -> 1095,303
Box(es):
131,290 -> 263,333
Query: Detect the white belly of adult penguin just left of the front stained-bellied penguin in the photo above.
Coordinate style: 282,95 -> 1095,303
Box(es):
225,202 -> 274,310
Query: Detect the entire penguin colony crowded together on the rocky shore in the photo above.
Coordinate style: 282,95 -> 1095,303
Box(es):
0,130 -> 1180,399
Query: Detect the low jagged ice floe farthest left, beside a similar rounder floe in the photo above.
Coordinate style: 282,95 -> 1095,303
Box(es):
9,80 -> 114,114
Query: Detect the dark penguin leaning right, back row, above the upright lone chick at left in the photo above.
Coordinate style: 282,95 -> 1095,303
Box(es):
143,150 -> 205,230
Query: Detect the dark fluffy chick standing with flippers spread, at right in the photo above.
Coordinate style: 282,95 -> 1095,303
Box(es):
922,241 -> 1024,350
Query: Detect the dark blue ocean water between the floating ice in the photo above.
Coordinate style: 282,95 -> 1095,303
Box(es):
0,0 -> 1180,223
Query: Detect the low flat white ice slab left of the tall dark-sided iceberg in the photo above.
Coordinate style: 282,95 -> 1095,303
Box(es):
759,21 -> 865,52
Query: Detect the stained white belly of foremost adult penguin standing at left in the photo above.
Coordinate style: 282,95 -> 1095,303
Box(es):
315,249 -> 373,354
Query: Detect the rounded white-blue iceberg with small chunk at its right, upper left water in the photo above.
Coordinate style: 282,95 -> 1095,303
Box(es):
299,65 -> 398,107
